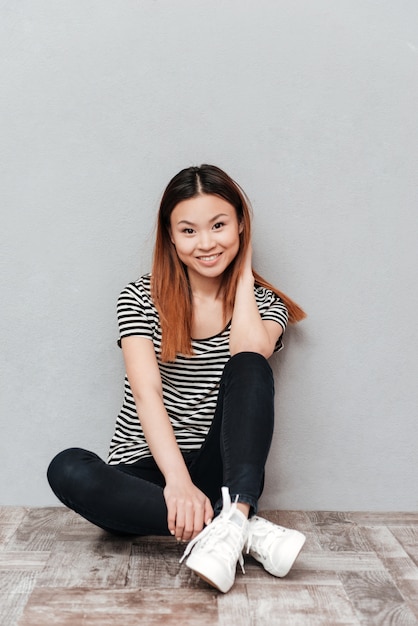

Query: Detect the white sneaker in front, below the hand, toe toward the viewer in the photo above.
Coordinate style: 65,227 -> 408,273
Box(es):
180,487 -> 248,593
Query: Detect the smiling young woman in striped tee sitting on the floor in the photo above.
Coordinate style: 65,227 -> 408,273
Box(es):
48,165 -> 305,593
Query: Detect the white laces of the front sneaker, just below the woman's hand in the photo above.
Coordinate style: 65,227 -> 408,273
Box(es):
180,503 -> 245,574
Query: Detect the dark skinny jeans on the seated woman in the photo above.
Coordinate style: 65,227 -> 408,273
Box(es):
48,352 -> 274,535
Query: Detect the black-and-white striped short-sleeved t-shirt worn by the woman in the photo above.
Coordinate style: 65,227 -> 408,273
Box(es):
108,274 -> 288,465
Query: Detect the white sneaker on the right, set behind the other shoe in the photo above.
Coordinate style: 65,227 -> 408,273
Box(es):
247,515 -> 306,578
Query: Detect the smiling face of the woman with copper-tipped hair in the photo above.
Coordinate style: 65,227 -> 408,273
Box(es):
170,194 -> 242,281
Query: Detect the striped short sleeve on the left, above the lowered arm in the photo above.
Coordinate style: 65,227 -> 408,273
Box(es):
117,282 -> 155,347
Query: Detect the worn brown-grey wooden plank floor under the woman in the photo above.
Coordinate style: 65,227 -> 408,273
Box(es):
0,507 -> 418,626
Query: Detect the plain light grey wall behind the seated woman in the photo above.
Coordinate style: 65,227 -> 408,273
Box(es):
0,0 -> 418,510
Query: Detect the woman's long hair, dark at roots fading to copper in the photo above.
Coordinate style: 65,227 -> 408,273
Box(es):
151,165 -> 306,361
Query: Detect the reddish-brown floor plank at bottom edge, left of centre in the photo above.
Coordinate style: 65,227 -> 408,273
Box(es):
18,588 -> 218,626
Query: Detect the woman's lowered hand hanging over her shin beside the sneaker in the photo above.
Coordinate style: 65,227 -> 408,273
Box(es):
164,480 -> 213,541
